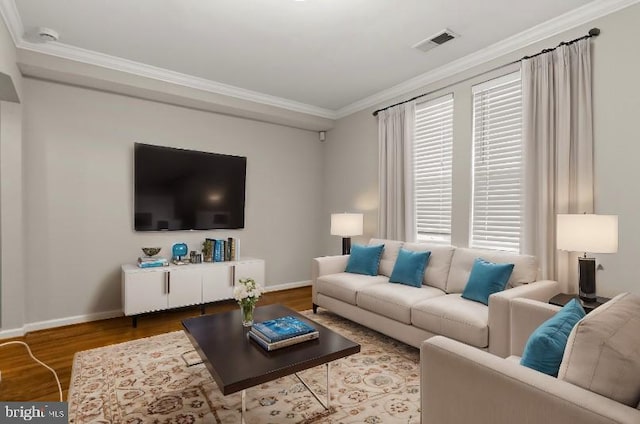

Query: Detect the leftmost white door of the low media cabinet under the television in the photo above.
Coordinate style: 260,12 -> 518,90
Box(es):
123,270 -> 168,315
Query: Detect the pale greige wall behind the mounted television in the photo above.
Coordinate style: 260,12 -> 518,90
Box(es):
23,78 -> 323,323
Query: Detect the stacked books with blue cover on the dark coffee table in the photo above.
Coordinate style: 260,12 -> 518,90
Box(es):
249,315 -> 319,350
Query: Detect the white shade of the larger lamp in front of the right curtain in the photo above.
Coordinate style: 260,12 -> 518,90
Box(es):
556,214 -> 618,253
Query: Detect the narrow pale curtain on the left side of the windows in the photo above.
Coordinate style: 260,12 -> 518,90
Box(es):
378,102 -> 416,241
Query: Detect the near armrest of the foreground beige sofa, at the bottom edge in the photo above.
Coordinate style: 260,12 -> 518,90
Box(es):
420,336 -> 640,424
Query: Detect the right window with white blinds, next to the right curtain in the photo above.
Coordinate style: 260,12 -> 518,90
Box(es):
469,72 -> 523,252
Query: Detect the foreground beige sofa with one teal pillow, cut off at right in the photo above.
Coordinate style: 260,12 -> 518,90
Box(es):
420,294 -> 640,424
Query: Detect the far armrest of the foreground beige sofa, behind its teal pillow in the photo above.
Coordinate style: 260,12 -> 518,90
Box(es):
510,299 -> 561,356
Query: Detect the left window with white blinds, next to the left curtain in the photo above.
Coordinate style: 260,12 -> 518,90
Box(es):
413,94 -> 453,243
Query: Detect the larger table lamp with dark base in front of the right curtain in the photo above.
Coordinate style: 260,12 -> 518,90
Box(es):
556,214 -> 618,302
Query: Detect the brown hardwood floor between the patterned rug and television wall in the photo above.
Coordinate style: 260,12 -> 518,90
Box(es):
0,287 -> 311,401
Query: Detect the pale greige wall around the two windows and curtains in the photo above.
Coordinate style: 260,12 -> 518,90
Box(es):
324,5 -> 640,296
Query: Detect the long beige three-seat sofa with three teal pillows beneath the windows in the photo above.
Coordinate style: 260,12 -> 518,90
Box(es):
312,239 -> 560,356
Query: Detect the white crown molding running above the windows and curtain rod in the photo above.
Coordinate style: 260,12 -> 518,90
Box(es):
336,0 -> 640,119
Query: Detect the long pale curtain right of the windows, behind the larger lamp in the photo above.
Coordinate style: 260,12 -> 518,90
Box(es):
521,38 -> 593,291
